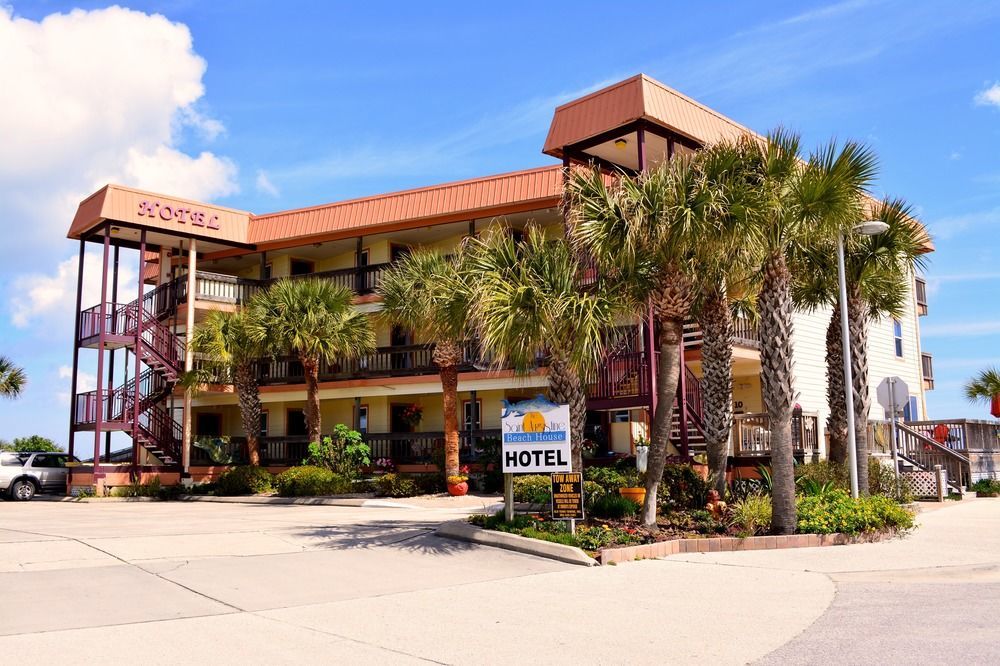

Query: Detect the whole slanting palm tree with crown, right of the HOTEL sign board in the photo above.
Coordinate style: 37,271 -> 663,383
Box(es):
566,156 -> 724,526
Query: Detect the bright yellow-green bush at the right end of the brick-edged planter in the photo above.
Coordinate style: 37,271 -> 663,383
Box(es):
797,490 -> 913,534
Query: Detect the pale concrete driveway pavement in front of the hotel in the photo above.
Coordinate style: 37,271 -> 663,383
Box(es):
0,500 -> 1000,665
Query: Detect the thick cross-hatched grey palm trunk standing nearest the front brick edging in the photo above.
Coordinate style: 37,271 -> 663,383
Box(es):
757,254 -> 796,534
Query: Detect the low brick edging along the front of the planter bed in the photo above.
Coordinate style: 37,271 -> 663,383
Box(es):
597,532 -> 895,564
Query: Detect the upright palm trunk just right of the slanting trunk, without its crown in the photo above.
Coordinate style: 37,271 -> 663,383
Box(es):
700,286 -> 733,494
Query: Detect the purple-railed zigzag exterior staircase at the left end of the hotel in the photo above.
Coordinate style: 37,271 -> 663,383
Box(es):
73,282 -> 185,467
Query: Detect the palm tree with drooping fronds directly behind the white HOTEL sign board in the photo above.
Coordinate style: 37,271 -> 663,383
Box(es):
466,224 -> 623,471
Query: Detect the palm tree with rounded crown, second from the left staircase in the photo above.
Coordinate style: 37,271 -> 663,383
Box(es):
249,278 -> 375,442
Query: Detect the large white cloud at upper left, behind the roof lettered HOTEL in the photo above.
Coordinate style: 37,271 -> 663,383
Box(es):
0,4 -> 237,326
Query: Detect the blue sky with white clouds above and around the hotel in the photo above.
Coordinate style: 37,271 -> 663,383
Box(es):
0,0 -> 1000,442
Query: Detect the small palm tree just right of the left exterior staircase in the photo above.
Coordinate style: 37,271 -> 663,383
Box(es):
184,307 -> 266,465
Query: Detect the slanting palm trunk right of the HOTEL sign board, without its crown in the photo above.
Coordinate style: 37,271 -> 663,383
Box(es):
642,319 -> 684,527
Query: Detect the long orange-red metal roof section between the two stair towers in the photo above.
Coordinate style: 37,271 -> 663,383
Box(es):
248,165 -> 562,244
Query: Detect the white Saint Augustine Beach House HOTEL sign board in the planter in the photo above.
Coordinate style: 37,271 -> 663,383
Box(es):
500,395 -> 573,474
